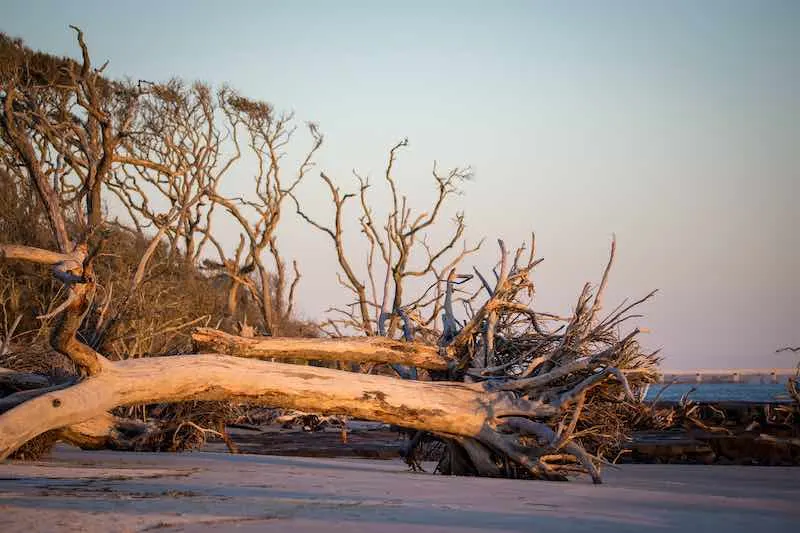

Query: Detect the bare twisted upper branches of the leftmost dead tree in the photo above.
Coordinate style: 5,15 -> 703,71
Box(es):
0,28 -> 183,247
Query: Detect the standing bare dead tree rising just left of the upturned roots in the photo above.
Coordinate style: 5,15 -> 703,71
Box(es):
296,139 -> 480,337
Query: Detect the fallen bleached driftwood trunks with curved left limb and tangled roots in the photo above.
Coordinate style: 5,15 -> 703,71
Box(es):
0,234 -> 654,482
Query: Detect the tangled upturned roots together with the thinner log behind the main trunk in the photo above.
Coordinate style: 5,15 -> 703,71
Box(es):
194,241 -> 658,481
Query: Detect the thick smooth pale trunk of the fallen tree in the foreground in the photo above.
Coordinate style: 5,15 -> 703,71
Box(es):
0,355 -> 528,459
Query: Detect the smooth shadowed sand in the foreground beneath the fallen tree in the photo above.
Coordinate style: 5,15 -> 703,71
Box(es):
0,447 -> 800,533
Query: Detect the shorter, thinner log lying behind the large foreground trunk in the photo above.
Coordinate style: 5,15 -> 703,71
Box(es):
192,328 -> 455,370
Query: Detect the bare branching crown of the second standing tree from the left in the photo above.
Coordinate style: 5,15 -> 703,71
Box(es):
109,80 -> 241,274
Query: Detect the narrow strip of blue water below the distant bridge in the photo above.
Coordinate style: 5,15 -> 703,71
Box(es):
645,383 -> 790,403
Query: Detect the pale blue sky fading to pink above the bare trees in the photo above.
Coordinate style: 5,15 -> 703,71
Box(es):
0,0 -> 800,370
